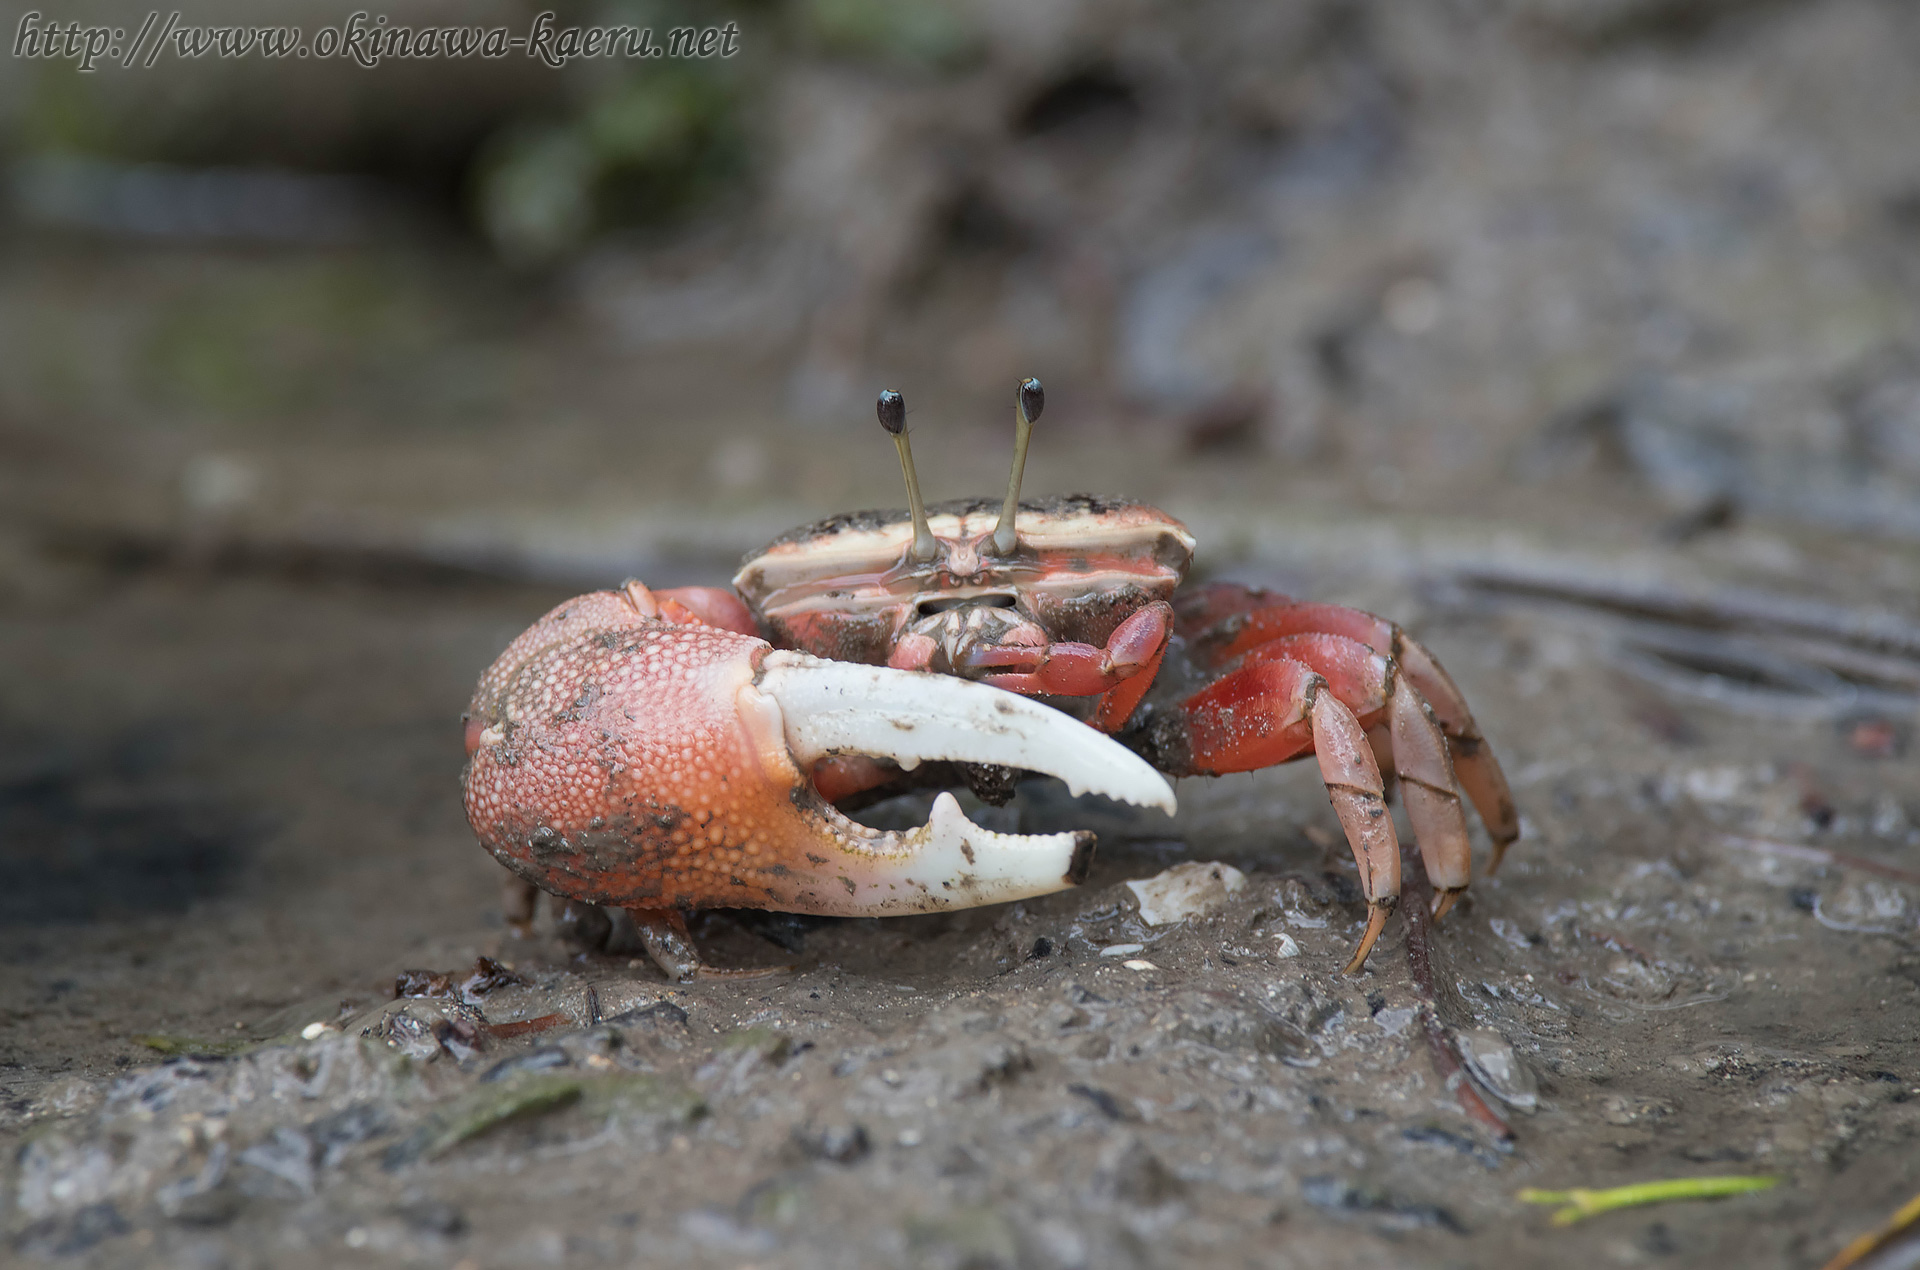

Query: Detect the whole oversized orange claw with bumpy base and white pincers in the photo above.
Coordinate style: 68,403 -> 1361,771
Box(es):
465,592 -> 1173,916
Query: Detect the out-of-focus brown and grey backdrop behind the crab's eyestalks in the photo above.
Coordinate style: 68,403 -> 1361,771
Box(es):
0,0 -> 1920,580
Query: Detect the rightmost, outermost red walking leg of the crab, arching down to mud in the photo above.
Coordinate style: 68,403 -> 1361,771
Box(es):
1177,582 -> 1521,872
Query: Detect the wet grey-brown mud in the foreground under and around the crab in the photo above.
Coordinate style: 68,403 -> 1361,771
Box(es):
0,332 -> 1920,1266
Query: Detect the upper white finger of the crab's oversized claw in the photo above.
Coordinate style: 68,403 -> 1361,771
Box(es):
758,651 -> 1175,810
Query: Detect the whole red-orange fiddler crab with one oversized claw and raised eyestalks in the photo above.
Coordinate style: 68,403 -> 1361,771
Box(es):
465,379 -> 1519,980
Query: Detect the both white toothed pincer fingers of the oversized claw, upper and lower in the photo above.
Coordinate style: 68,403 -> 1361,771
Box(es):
741,651 -> 1175,915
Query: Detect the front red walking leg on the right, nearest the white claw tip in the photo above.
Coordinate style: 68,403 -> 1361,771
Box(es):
1146,655 -> 1400,974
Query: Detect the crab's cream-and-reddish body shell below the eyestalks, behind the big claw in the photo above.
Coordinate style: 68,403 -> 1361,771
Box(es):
733,494 -> 1194,665
